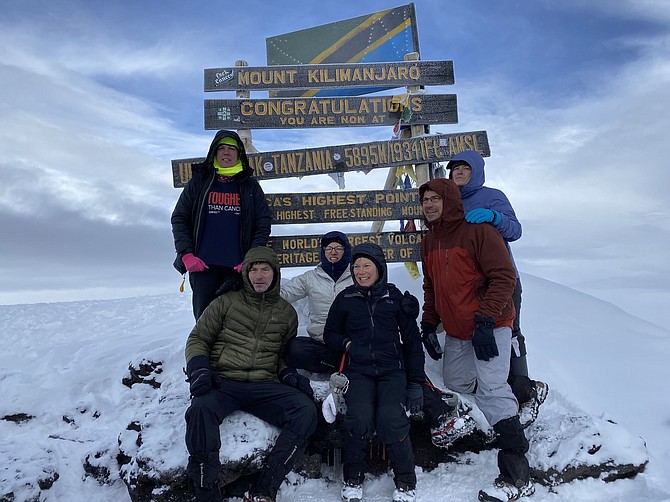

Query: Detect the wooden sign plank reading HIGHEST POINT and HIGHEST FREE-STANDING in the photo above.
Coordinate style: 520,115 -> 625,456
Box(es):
266,188 -> 422,225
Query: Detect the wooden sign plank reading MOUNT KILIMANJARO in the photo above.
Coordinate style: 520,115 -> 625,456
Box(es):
205,61 -> 454,92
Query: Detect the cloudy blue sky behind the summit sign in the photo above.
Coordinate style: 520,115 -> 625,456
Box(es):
0,0 -> 670,325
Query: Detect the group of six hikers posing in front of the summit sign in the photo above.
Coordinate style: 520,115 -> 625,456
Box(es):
172,131 -> 548,502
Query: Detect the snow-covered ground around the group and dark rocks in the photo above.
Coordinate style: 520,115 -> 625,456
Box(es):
0,265 -> 670,502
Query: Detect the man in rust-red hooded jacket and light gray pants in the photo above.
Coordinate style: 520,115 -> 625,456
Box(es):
419,178 -> 535,502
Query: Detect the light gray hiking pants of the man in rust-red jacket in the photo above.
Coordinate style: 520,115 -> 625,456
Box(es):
442,327 -> 519,425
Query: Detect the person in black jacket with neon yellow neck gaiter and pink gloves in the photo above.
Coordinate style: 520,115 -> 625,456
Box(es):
171,130 -> 272,320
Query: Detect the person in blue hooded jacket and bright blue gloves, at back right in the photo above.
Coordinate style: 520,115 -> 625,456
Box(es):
422,150 -> 549,427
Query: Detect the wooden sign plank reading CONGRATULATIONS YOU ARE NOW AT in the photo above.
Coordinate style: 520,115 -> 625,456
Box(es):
205,94 -> 458,129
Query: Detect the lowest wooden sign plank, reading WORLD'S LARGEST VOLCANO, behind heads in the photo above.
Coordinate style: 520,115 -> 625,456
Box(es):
269,232 -> 424,267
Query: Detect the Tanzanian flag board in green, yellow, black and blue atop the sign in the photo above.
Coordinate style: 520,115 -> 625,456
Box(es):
265,3 -> 419,97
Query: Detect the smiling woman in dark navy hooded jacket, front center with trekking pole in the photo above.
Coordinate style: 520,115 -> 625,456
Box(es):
323,243 -> 424,502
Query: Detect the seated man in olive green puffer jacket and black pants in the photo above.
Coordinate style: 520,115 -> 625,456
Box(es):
185,246 -> 317,502
